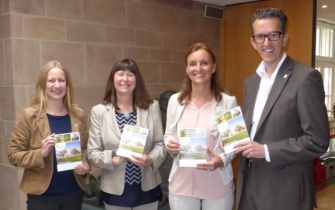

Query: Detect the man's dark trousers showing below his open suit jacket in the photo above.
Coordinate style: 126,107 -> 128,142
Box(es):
238,166 -> 257,210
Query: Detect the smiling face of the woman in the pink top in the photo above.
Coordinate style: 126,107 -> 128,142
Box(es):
186,49 -> 216,85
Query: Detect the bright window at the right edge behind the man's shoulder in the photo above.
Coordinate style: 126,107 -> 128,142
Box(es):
315,20 -> 335,114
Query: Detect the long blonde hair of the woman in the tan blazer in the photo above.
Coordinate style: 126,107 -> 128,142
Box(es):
30,60 -> 73,112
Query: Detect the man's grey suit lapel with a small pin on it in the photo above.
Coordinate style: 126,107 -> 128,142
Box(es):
256,57 -> 293,133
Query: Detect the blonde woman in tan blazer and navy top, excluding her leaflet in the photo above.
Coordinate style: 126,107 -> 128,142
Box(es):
8,61 -> 90,210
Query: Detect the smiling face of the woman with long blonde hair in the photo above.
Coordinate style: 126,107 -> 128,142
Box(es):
45,67 -> 67,102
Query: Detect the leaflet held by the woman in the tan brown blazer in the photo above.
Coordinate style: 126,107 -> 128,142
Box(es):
55,132 -> 82,171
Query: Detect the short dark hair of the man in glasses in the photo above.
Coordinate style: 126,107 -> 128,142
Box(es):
250,7 -> 287,34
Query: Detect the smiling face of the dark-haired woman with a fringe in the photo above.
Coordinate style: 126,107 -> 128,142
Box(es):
114,69 -> 136,95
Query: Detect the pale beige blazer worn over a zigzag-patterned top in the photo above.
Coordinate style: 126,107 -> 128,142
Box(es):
87,101 -> 166,195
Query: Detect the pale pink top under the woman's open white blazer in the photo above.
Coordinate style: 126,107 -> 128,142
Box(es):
169,102 -> 231,200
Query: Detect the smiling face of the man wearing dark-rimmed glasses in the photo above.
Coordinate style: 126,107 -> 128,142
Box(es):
250,18 -> 288,71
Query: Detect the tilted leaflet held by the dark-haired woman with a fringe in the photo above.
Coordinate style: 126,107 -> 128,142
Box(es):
116,125 -> 149,158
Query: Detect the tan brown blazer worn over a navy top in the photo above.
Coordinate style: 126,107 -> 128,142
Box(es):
8,106 -> 90,195
